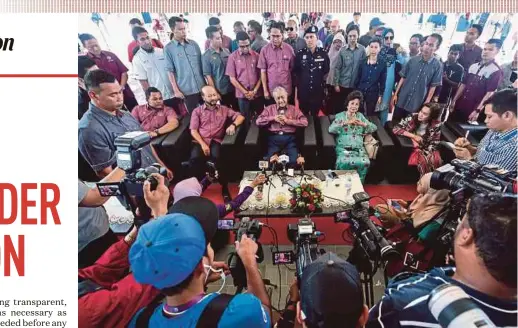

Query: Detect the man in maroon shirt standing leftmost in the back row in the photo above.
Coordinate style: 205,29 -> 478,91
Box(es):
79,33 -> 138,111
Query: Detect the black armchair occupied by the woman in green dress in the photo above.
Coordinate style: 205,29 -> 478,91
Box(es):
319,115 -> 394,183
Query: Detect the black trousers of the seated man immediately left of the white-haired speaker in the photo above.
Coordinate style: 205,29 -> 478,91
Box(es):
190,140 -> 230,194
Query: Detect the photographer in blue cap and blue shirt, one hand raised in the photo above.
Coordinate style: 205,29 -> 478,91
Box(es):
129,196 -> 270,328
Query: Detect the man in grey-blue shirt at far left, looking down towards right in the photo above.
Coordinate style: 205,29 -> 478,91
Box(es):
79,69 -> 173,179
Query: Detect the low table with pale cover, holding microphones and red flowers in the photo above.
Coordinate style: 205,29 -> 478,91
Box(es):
234,170 -> 364,218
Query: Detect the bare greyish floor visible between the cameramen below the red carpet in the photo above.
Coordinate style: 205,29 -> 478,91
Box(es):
208,245 -> 385,310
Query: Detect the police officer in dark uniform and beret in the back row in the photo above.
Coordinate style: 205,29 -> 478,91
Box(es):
293,25 -> 330,116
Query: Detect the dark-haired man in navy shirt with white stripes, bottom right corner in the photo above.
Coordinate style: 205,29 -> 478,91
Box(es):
367,194 -> 518,327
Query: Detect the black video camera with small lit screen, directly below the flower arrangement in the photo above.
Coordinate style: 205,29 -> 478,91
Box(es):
288,218 -> 320,280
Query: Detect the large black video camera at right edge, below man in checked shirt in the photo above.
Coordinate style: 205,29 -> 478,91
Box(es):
430,159 -> 516,198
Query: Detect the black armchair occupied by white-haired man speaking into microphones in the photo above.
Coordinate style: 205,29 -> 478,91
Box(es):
243,116 -> 318,171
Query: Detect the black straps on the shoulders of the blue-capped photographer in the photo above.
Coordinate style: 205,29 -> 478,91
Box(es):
136,294 -> 234,328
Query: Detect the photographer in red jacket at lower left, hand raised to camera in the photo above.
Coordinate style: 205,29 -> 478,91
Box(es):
78,173 -> 169,328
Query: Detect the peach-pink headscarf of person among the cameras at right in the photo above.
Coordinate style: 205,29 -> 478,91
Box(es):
408,173 -> 450,227
